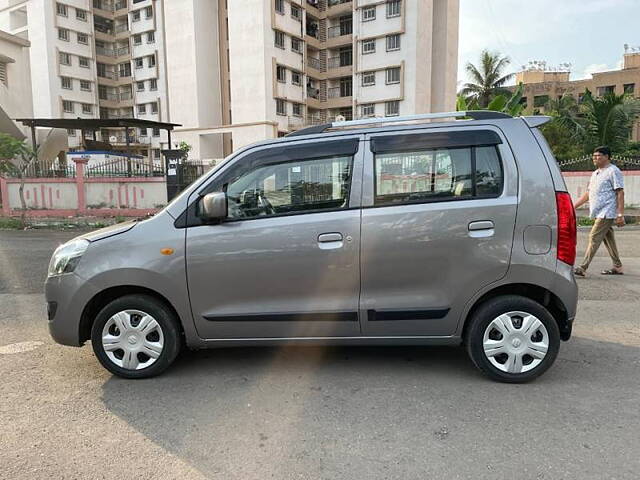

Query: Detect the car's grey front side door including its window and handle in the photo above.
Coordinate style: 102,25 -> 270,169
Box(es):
186,138 -> 362,339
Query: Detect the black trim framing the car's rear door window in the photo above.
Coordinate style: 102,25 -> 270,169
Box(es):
370,141 -> 506,208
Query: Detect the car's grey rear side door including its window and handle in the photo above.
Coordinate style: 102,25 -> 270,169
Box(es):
360,127 -> 518,336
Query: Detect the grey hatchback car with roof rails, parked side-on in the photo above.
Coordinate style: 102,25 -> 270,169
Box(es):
46,112 -> 577,382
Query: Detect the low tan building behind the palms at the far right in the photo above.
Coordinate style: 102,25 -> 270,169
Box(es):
511,50 -> 640,141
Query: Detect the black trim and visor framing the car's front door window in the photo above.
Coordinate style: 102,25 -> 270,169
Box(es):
174,135 -> 362,228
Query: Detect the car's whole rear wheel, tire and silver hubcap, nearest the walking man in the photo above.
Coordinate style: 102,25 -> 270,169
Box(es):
465,295 -> 560,383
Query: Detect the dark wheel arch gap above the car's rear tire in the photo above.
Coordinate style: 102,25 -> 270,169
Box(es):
462,283 -> 571,340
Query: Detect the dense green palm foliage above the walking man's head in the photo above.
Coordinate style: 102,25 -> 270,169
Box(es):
580,90 -> 640,152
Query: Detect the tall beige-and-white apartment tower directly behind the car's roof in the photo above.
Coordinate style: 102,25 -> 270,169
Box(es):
165,0 -> 459,158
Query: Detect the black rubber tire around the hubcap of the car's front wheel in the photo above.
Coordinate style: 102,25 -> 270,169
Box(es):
91,295 -> 182,378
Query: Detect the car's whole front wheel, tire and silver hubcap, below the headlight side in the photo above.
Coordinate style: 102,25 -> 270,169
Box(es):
91,295 -> 181,378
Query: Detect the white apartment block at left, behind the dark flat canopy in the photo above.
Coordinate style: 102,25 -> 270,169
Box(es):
0,0 -> 168,160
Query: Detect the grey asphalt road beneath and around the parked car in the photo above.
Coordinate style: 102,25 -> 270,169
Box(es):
0,228 -> 640,480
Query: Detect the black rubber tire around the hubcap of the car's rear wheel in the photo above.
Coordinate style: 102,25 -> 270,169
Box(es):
464,295 -> 560,383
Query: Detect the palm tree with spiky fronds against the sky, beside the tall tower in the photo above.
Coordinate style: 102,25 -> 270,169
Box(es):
460,50 -> 513,108
